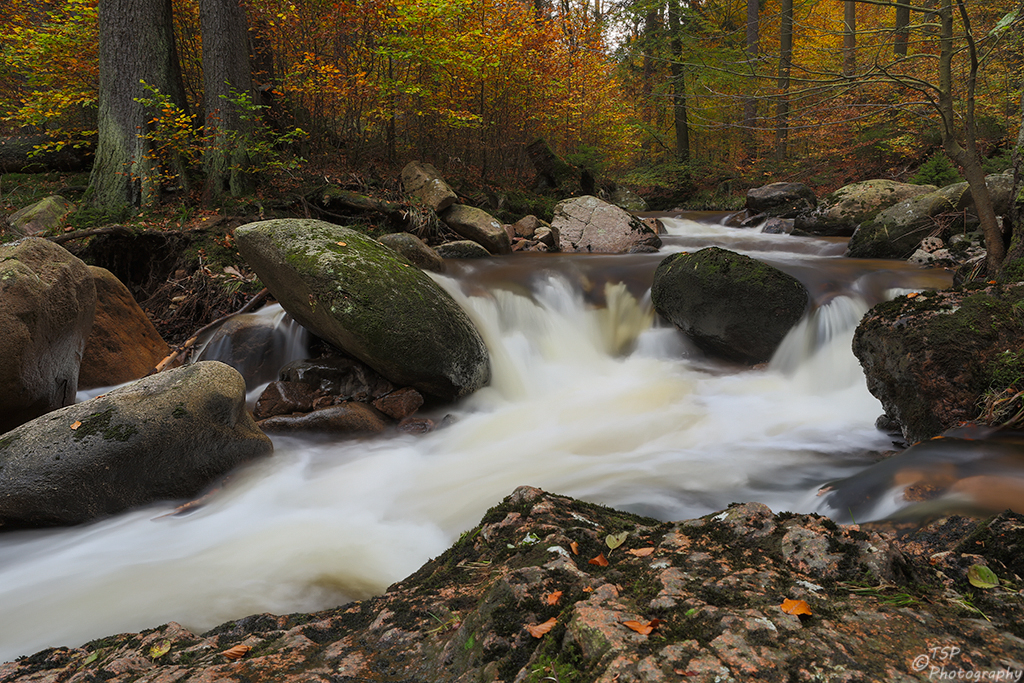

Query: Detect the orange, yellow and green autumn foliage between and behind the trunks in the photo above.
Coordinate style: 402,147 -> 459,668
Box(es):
0,0 -> 1022,187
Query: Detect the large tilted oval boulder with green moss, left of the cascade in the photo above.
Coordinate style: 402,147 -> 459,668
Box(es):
234,219 -> 490,399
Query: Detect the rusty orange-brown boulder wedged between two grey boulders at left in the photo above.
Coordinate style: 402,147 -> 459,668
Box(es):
78,265 -> 169,389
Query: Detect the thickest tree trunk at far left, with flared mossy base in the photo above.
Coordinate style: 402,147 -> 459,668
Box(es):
87,0 -> 184,212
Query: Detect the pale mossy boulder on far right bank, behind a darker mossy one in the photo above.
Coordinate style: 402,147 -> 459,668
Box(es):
794,179 -> 938,237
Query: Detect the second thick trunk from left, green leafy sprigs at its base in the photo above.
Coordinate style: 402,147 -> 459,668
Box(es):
199,0 -> 256,199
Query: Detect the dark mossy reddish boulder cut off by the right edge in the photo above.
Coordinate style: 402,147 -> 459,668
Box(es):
853,284 -> 1024,443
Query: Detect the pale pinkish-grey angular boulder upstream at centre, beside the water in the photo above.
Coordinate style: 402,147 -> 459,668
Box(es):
551,195 -> 662,254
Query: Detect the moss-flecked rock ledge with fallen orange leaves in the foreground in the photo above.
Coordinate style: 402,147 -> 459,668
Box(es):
0,487 -> 1024,683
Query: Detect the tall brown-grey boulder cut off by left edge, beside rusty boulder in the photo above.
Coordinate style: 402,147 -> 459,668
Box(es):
0,238 -> 96,432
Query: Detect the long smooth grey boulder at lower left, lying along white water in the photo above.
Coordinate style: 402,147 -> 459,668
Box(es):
0,361 -> 273,528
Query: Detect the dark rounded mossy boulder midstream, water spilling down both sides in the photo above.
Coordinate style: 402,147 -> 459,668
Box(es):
650,247 -> 809,365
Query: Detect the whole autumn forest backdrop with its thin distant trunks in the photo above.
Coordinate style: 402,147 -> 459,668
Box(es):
0,0 -> 1024,208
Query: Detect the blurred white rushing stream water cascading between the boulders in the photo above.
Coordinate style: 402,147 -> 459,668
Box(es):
0,215 -> 942,660
